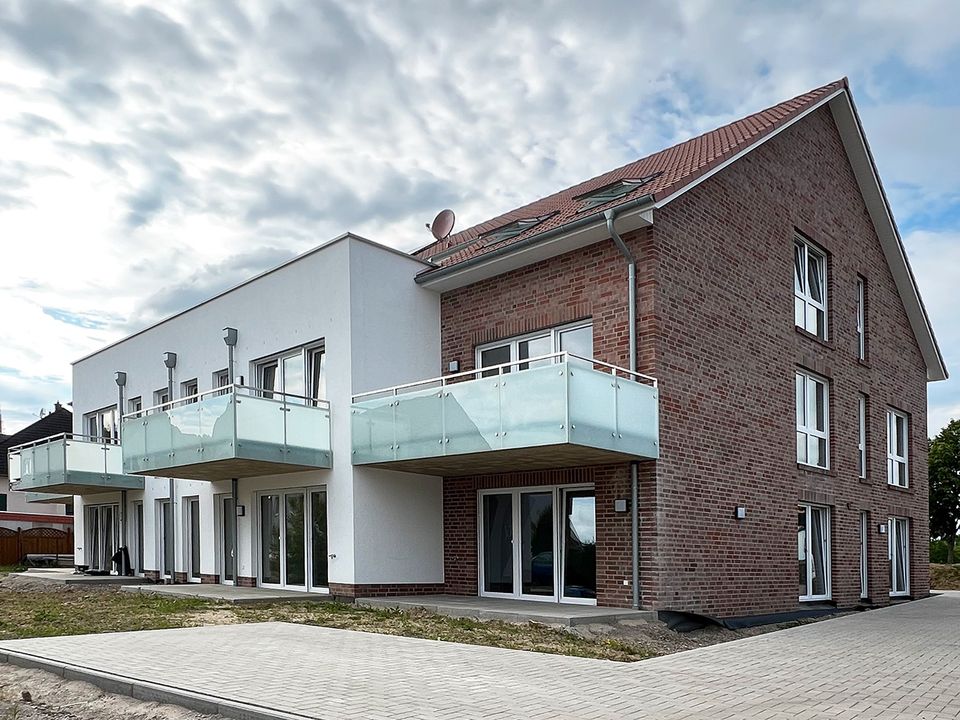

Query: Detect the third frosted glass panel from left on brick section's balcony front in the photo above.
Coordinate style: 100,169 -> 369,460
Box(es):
437,375 -> 502,455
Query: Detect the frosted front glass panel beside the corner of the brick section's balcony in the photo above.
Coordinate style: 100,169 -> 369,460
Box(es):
500,363 -> 567,448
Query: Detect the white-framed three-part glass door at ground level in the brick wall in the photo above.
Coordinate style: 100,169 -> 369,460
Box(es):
480,487 -> 597,604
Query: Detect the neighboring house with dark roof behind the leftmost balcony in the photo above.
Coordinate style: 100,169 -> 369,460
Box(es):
0,403 -> 73,530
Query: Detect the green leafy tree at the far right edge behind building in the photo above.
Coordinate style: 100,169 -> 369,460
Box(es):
929,420 -> 960,565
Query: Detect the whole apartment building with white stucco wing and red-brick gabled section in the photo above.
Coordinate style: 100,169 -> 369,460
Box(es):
9,80 -> 947,618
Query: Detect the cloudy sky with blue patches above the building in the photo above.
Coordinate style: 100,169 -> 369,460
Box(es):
0,0 -> 960,432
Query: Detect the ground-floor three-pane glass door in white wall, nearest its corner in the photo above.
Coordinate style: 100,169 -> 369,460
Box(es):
259,489 -> 329,591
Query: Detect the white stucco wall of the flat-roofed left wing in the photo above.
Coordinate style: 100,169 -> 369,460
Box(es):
73,236 -> 443,584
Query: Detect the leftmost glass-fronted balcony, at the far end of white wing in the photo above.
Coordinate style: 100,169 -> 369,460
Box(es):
7,434 -> 143,502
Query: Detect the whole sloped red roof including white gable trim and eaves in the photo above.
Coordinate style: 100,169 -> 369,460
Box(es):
413,78 -> 949,380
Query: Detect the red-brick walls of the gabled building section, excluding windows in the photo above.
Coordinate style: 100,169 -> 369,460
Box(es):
441,108 -> 929,617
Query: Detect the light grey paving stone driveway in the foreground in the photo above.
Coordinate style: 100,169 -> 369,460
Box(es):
0,593 -> 960,720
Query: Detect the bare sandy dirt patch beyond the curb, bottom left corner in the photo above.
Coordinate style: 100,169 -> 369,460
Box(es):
0,665 -> 222,720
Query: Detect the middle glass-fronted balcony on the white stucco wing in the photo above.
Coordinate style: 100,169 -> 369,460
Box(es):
121,385 -> 332,481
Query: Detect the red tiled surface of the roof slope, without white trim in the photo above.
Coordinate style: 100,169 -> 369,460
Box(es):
413,78 -> 848,273
